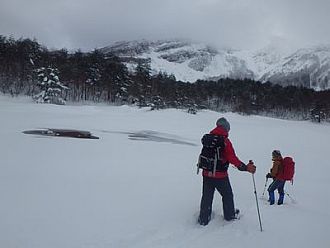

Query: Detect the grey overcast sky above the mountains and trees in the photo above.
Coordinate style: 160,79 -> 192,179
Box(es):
0,0 -> 330,50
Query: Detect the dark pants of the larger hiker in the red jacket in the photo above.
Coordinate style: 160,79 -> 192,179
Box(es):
199,177 -> 235,224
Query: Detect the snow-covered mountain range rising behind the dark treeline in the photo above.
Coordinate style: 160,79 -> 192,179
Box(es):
100,40 -> 330,90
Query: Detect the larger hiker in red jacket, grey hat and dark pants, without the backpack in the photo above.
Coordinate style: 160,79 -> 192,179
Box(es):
198,117 -> 256,226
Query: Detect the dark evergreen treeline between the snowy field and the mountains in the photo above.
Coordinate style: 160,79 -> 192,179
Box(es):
0,36 -> 330,121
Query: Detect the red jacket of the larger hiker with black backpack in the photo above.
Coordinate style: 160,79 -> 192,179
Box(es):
203,127 -> 242,178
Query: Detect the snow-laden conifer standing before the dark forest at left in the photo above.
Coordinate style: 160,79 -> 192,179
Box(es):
33,67 -> 69,105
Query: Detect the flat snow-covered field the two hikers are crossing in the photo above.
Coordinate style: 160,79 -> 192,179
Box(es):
0,96 -> 330,248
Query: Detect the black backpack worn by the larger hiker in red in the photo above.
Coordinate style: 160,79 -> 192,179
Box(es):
197,134 -> 229,174
